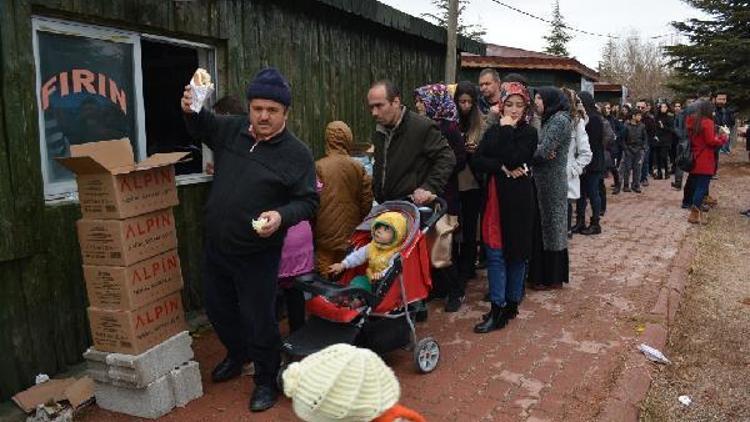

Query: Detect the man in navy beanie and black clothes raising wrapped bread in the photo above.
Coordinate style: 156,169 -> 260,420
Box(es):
180,68 -> 318,412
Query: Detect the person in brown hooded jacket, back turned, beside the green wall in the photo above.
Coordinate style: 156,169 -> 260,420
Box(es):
314,121 -> 372,274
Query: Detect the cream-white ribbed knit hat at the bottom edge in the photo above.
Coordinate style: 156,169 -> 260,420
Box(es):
283,344 -> 401,422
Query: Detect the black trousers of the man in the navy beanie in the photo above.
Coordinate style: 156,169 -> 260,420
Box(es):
203,239 -> 281,386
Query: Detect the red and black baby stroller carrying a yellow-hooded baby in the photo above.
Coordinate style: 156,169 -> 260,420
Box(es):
282,198 -> 446,373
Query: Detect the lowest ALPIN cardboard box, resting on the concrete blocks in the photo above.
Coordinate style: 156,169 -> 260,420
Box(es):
88,292 -> 185,355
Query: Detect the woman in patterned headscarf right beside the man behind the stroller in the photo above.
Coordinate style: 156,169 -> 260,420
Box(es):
414,84 -> 466,312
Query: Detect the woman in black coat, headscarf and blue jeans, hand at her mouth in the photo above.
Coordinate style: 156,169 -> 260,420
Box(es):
472,82 -> 537,333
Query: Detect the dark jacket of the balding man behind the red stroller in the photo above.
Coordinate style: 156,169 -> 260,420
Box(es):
372,109 -> 456,202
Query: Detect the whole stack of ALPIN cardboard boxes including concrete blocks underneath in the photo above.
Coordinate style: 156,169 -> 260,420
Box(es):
59,139 -> 203,418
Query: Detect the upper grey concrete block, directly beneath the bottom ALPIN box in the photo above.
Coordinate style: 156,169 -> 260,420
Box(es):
83,331 -> 194,388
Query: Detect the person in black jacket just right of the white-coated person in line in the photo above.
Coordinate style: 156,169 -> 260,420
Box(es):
576,91 -> 605,235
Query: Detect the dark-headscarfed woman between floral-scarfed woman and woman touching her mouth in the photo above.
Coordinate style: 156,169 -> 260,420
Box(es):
453,81 -> 487,280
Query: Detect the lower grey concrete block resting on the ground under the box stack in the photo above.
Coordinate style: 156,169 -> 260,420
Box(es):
95,361 -> 203,419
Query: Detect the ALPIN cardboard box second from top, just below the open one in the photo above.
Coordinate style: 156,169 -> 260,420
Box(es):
77,208 -> 177,267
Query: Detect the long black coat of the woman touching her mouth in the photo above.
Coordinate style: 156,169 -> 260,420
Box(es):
471,124 -> 537,260
